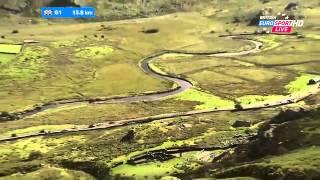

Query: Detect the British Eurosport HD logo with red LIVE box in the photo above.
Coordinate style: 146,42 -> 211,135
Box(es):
259,13 -> 304,34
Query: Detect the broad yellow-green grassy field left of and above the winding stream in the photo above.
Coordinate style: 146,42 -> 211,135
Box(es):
0,13 -> 255,111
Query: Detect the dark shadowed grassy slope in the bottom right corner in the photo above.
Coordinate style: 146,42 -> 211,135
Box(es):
213,109 -> 320,179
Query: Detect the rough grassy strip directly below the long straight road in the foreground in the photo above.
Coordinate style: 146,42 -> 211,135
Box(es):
0,108 -> 274,177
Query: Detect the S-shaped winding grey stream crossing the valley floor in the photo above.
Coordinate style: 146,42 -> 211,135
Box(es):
6,36 -> 262,120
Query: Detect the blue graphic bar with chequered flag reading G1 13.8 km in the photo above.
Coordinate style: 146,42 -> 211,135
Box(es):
41,7 -> 96,19
